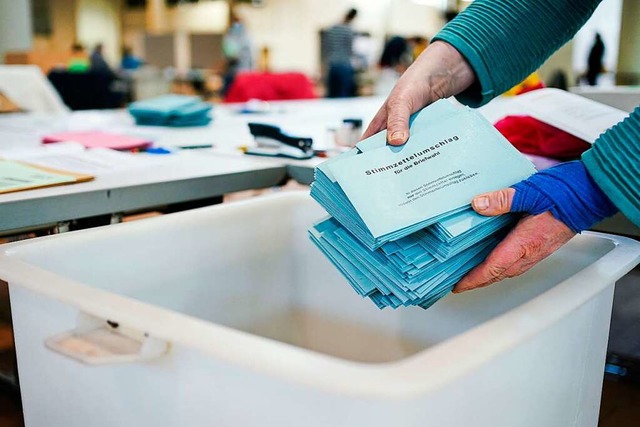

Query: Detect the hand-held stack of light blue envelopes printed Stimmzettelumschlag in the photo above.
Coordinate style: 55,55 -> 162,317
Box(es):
309,100 -> 535,308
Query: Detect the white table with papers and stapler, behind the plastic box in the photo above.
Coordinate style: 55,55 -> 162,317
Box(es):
0,98 -> 382,232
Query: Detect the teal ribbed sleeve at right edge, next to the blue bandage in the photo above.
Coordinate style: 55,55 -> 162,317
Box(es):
582,107 -> 640,227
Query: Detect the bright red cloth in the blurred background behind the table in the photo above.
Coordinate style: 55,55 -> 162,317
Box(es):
224,73 -> 317,102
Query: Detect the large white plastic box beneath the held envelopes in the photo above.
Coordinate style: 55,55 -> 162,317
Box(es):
0,193 -> 640,427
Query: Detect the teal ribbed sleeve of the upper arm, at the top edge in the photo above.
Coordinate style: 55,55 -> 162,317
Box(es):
433,0 -> 601,107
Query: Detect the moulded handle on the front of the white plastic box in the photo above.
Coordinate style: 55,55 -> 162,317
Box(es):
45,313 -> 169,365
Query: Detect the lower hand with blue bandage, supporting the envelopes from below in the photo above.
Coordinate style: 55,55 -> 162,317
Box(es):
453,161 -> 617,293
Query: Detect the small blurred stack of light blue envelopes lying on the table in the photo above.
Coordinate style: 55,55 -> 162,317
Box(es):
128,95 -> 212,127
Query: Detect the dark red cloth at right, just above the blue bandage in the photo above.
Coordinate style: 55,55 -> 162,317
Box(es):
495,116 -> 591,160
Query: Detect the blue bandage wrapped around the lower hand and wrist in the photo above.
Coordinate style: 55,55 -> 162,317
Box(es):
511,160 -> 618,233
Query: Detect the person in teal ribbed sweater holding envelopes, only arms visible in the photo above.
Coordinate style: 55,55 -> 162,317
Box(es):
363,0 -> 640,292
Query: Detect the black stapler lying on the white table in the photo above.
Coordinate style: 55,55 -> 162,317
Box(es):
245,123 -> 314,159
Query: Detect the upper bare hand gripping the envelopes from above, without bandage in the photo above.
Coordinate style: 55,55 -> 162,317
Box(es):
362,41 -> 476,145
